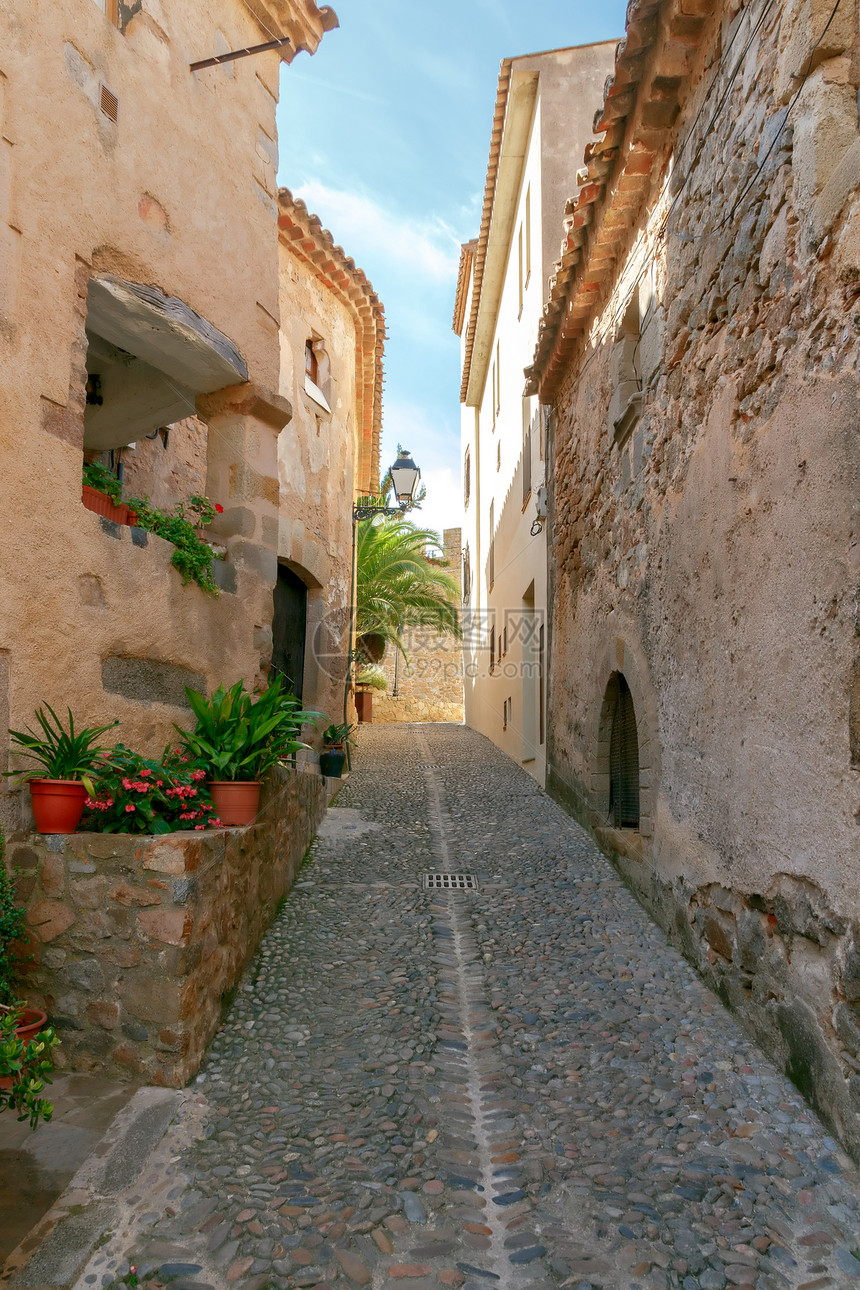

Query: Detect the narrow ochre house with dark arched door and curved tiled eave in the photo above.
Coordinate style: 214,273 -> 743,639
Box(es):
273,188 -> 386,722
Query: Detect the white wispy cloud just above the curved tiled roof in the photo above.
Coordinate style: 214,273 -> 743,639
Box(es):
294,179 -> 460,283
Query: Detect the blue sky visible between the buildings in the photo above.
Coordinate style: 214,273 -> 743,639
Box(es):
279,0 -> 625,529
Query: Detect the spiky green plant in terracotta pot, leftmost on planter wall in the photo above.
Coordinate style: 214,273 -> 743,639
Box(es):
5,703 -> 120,833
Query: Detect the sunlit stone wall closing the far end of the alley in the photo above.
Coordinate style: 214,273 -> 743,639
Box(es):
373,529 -> 463,724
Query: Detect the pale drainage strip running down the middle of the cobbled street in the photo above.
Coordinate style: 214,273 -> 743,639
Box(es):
418,735 -> 538,1290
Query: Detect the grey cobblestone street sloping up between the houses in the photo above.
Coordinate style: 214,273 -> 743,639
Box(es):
77,725 -> 860,1290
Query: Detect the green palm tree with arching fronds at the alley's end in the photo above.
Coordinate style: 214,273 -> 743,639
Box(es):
356,519 -> 463,662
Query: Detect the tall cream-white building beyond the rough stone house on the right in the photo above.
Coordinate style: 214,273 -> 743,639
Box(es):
454,43 -> 615,784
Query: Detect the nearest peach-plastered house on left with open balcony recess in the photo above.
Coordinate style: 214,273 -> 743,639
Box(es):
0,0 -> 337,826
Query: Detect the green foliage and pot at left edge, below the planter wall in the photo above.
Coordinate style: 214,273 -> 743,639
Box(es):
0,833 -> 57,1129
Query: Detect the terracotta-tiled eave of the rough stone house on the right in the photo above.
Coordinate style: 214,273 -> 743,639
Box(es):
526,0 -> 721,402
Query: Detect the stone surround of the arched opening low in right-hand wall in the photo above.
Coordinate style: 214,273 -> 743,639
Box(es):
588,636 -> 659,859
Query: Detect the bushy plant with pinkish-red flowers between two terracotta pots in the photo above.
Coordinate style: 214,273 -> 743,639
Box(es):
83,743 -> 220,833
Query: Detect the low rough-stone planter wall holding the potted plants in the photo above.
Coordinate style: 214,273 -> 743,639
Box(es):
8,771 -> 325,1087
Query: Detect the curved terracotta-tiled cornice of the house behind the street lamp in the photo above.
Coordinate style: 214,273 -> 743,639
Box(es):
277,188 -> 386,495
